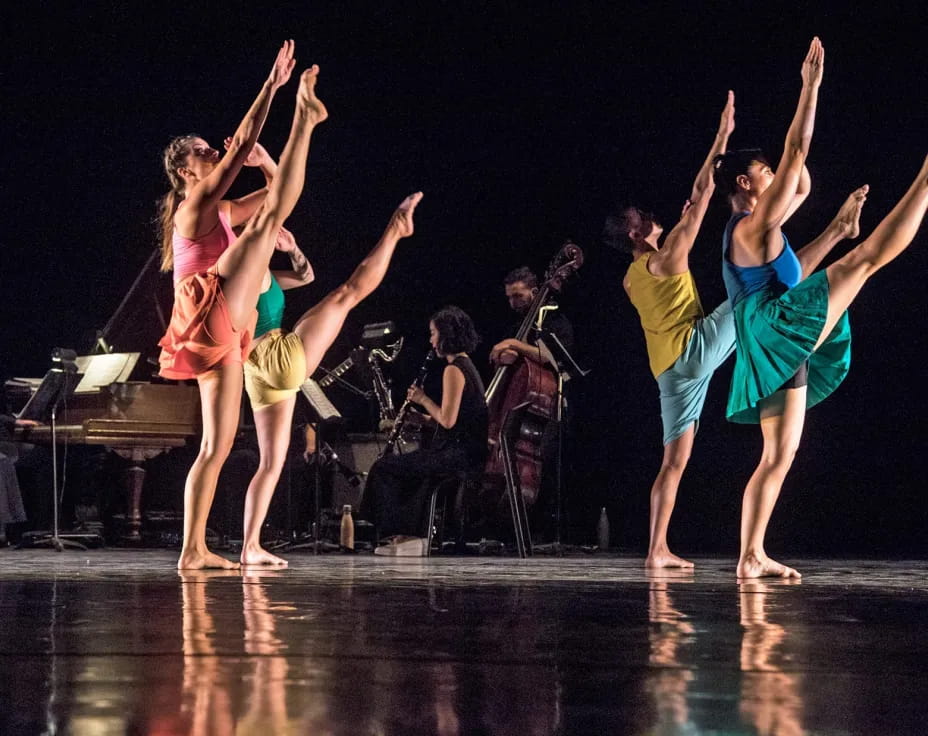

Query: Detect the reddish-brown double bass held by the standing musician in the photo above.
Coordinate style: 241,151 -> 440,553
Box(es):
485,241 -> 583,507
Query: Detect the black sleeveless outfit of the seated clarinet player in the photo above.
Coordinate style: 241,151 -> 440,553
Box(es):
362,355 -> 487,537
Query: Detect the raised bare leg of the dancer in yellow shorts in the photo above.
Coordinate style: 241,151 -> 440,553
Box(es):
293,192 -> 422,376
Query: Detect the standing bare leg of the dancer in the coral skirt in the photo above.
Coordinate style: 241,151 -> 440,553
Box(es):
177,363 -> 242,570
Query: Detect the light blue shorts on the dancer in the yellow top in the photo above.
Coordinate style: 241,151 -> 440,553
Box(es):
657,301 -> 735,445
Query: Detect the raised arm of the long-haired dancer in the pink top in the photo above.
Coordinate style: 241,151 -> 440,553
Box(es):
175,41 -> 295,230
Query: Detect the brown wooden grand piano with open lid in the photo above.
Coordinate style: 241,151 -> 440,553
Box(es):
6,250 -> 200,543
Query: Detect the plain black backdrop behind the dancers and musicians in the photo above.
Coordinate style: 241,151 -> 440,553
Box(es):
0,2 -> 928,556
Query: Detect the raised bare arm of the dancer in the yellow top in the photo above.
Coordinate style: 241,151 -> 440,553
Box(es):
651,90 -> 735,276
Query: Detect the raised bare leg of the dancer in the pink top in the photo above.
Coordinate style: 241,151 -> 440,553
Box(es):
216,66 -> 328,329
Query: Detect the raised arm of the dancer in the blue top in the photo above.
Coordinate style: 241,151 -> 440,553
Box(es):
736,36 -> 825,240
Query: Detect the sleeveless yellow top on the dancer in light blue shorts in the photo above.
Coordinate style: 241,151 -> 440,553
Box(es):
626,253 -> 704,378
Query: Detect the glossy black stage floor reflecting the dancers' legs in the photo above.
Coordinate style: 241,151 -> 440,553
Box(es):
0,550 -> 928,736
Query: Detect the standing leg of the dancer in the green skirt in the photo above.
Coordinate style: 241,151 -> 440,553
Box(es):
737,386 -> 806,578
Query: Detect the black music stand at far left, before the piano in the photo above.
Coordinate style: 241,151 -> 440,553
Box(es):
17,348 -> 87,552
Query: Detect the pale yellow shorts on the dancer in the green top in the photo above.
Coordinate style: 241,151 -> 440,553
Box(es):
245,330 -> 306,409
